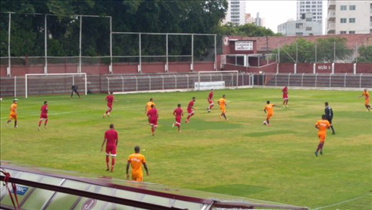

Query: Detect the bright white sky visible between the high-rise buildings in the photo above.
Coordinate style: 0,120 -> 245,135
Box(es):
244,0 -> 327,34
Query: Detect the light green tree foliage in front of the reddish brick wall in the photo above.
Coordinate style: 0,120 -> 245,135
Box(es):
273,37 -> 352,63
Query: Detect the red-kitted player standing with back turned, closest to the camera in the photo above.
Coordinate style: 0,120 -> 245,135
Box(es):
101,124 -> 119,172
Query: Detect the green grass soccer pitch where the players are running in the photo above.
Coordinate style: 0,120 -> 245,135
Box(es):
1,89 -> 372,210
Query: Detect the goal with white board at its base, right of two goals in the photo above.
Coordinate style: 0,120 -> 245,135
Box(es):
195,70 -> 239,90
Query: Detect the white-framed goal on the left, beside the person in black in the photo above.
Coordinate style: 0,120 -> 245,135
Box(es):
25,73 -> 88,98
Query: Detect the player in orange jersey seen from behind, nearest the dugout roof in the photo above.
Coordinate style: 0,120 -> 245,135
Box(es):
126,146 -> 149,182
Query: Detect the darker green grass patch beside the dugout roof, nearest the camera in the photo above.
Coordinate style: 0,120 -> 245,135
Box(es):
197,184 -> 268,197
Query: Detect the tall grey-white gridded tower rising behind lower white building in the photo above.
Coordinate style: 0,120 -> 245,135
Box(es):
297,0 -> 323,23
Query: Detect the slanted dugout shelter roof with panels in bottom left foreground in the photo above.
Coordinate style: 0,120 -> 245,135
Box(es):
0,162 -> 307,210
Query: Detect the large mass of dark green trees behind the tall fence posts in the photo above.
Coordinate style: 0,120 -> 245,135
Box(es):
0,0 -> 227,59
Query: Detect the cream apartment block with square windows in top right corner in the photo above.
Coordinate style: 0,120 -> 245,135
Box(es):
327,0 -> 372,34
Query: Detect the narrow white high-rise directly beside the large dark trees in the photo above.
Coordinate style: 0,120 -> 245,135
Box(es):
223,0 -> 245,25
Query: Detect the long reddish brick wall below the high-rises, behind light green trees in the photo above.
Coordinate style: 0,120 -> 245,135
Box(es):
229,33 -> 372,52
